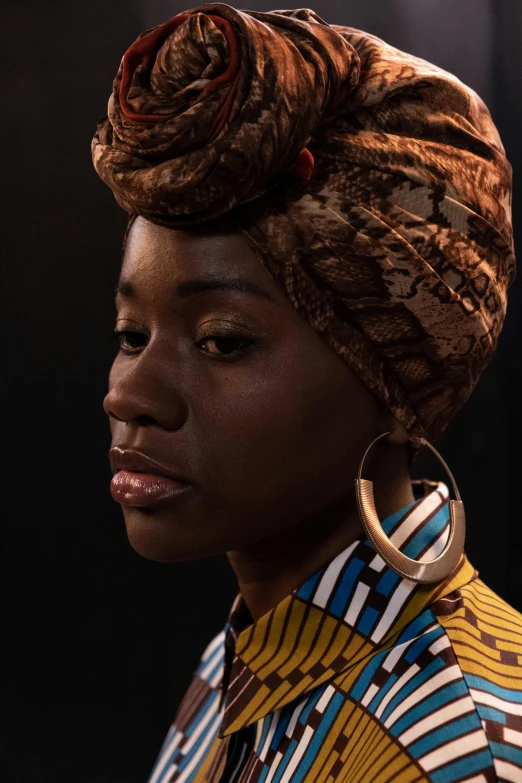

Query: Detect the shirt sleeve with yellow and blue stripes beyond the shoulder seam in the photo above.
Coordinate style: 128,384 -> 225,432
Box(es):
431,577 -> 522,781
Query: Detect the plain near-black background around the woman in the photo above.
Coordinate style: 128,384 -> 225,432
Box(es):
0,0 -> 522,783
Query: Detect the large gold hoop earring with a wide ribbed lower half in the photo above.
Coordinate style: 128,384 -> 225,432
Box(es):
355,431 -> 466,584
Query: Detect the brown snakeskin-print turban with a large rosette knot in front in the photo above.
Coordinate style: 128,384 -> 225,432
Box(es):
92,3 -> 515,441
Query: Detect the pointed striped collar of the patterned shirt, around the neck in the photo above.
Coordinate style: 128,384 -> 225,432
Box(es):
219,480 -> 477,737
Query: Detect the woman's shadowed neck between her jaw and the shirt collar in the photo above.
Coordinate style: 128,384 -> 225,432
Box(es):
227,446 -> 414,621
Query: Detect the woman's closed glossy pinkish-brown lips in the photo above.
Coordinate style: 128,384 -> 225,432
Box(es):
109,446 -> 192,508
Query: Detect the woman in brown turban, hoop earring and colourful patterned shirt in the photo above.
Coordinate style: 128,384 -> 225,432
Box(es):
92,3 -> 522,783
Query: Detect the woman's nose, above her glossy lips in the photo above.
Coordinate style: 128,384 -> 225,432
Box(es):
103,351 -> 187,430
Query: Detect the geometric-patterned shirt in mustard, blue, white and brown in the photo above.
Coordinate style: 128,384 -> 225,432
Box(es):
149,481 -> 522,783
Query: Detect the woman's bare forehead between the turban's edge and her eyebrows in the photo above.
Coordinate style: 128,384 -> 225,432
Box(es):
121,217 -> 275,290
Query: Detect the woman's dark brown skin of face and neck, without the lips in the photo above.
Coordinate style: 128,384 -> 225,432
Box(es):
104,216 -> 414,620
